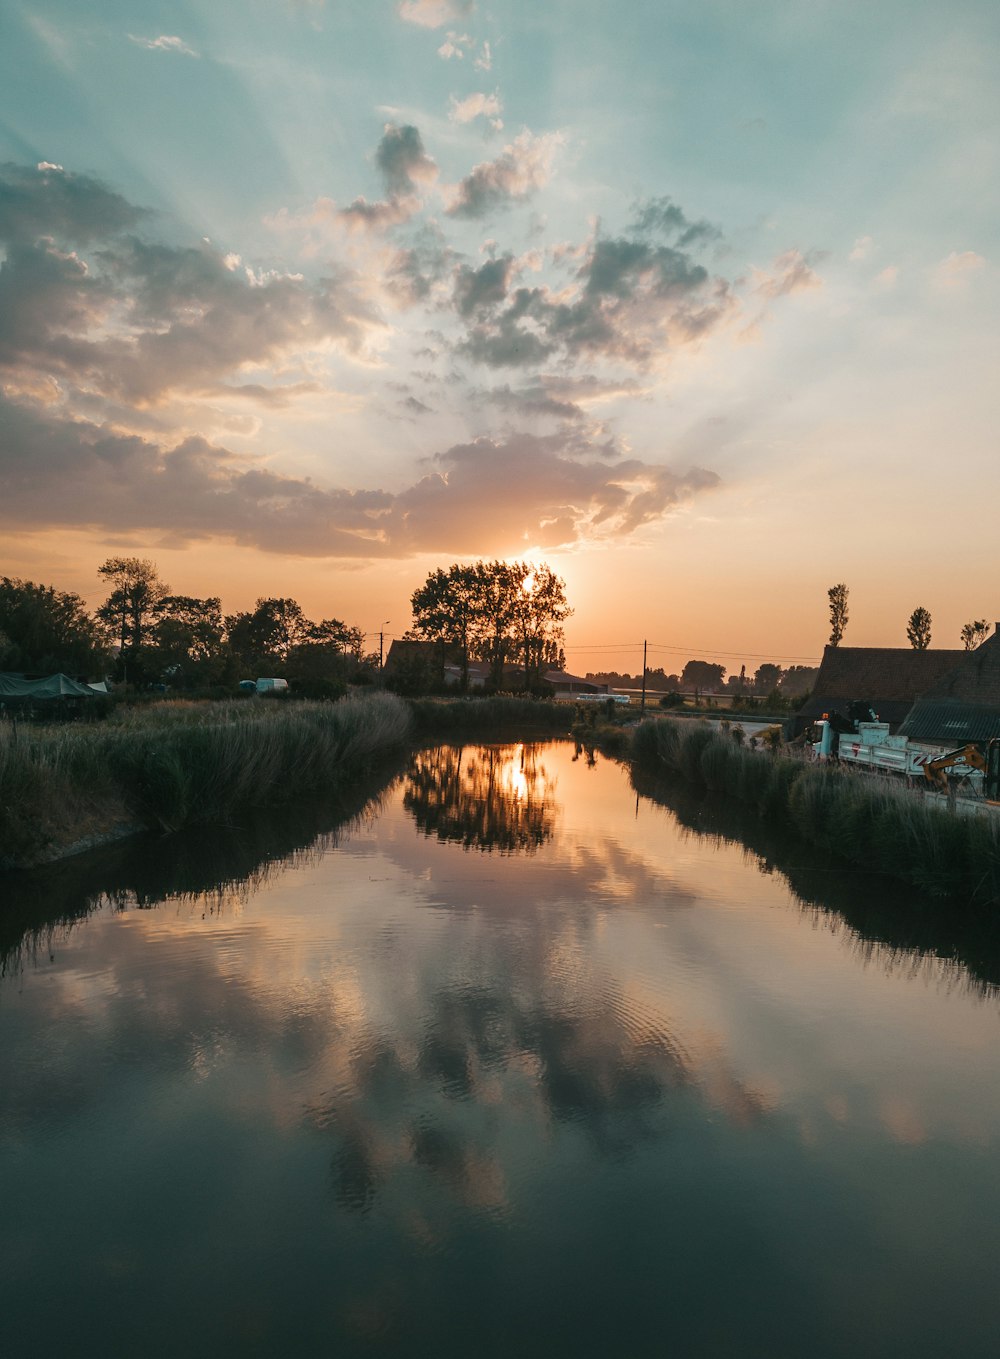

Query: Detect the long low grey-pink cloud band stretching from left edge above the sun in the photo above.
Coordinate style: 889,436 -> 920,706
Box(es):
0,398 -> 719,557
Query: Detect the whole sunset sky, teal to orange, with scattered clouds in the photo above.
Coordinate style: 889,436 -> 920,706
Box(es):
0,0 -> 1000,671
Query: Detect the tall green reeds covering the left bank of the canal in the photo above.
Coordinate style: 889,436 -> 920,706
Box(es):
0,694 -> 410,867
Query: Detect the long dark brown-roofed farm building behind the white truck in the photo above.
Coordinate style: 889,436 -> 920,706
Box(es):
795,647 -> 981,734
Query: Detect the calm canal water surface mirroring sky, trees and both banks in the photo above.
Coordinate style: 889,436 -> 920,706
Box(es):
0,745 -> 1000,1359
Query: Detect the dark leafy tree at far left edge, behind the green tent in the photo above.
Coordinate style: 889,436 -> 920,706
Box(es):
0,576 -> 109,678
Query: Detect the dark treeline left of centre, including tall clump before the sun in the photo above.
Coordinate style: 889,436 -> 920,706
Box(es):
0,557 -> 572,699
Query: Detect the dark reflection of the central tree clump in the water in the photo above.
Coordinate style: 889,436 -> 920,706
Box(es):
404,745 -> 557,853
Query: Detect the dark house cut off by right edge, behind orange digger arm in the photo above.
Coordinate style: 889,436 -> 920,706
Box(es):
899,622 -> 1000,746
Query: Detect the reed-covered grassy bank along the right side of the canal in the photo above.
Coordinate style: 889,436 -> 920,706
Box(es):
628,720 -> 1000,904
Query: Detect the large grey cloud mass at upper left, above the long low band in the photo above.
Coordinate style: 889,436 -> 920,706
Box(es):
0,167 -> 380,405
